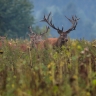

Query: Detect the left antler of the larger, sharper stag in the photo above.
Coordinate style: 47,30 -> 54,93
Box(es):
41,12 -> 63,31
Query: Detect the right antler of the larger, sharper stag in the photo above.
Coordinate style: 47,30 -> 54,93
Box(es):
65,16 -> 80,33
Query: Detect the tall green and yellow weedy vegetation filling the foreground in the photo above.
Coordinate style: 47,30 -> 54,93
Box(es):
0,40 -> 96,96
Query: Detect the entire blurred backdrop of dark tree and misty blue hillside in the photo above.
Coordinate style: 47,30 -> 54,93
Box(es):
0,0 -> 96,40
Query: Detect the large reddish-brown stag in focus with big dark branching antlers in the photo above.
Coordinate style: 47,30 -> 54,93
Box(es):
41,12 -> 79,47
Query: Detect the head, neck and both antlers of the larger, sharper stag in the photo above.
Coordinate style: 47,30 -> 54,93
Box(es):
41,12 -> 79,46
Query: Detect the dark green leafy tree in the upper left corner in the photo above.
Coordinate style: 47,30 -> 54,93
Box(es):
0,0 -> 34,37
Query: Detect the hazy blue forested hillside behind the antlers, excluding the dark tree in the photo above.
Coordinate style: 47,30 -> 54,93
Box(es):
33,0 -> 96,40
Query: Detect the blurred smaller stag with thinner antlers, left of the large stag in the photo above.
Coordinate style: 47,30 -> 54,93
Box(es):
28,26 -> 49,49
